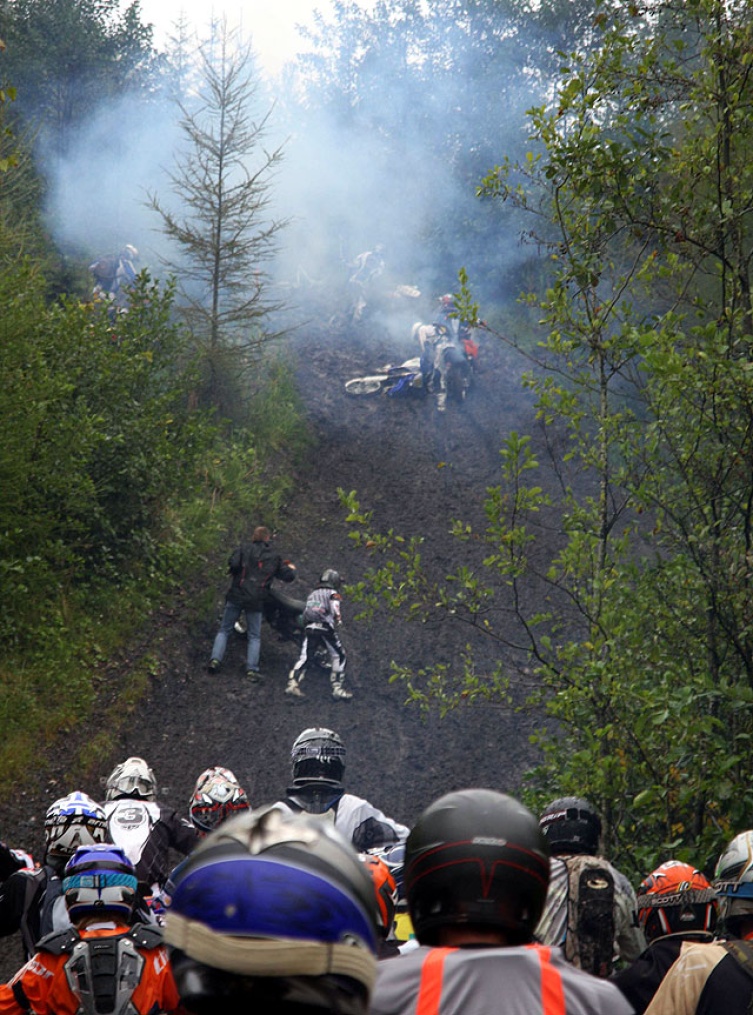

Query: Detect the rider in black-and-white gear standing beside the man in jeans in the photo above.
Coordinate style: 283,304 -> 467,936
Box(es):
285,567 -> 353,701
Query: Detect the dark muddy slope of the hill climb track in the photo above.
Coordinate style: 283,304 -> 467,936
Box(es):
0,294 -> 556,971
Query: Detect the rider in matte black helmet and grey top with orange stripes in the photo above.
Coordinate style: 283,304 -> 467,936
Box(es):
371,789 -> 632,1015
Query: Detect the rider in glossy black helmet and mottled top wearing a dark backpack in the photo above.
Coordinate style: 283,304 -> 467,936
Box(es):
536,797 -> 645,975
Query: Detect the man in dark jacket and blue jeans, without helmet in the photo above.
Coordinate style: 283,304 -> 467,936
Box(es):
209,525 -> 295,680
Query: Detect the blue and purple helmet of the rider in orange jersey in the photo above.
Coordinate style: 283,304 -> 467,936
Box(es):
63,842 -> 138,924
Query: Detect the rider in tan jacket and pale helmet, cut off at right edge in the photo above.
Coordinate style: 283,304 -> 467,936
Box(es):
645,830 -> 753,1015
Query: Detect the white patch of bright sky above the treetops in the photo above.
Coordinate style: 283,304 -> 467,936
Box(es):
134,0 -> 330,75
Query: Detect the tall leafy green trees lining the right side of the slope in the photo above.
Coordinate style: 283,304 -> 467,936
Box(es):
347,0 -> 753,871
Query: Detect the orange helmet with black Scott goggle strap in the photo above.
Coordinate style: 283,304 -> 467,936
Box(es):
637,860 -> 718,941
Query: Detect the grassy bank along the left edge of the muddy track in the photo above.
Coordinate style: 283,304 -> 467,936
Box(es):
0,360 -> 311,797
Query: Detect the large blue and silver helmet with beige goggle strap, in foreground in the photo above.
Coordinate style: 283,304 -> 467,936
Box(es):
164,807 -> 377,1015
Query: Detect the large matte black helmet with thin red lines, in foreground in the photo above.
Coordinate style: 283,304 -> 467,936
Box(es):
404,790 -> 549,945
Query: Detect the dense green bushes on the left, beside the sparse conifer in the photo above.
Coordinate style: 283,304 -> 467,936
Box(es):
0,258 -> 215,642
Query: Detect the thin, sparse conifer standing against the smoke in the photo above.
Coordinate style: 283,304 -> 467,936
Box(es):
151,22 -> 285,414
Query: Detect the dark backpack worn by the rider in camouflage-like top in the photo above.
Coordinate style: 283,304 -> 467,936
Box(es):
560,856 -> 615,978
